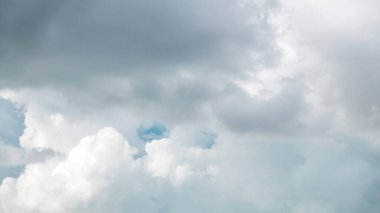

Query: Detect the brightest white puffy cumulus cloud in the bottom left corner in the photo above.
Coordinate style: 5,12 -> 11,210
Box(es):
0,128 -> 135,212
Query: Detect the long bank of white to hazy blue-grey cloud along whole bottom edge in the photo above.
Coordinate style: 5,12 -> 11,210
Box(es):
0,124 -> 380,212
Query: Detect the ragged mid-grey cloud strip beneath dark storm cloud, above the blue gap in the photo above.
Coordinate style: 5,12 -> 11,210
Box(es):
52,72 -> 229,126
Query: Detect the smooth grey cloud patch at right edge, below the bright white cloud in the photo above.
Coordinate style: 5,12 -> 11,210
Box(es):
327,39 -> 380,127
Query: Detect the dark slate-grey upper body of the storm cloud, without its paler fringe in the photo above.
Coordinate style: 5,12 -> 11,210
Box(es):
0,0 -> 272,86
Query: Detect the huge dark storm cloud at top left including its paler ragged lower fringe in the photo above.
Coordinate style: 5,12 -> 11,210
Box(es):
0,0 -> 284,133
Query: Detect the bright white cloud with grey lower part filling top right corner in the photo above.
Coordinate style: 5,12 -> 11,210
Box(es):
284,0 -> 380,128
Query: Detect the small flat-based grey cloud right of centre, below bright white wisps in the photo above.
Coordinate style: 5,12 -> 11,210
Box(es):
215,81 -> 307,133
